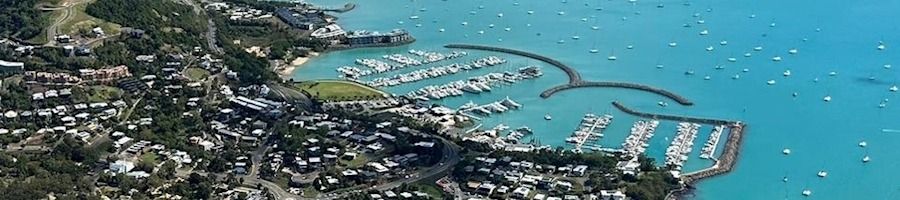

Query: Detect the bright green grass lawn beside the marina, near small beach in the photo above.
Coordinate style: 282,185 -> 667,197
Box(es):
294,80 -> 385,101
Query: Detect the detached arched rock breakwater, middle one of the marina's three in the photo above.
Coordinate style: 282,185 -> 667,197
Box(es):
541,81 -> 694,106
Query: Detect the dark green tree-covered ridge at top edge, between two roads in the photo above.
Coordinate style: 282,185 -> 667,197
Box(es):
87,0 -> 206,34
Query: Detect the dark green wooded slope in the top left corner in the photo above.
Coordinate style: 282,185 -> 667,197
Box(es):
0,0 -> 47,39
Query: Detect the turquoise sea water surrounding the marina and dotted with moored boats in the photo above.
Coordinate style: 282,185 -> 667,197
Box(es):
294,0 -> 900,200
